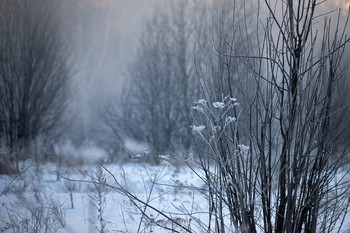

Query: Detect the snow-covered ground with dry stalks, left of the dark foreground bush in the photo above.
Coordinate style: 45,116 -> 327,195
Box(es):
0,163 -> 208,233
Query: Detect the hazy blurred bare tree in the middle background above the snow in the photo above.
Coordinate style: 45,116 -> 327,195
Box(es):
106,1 -> 198,160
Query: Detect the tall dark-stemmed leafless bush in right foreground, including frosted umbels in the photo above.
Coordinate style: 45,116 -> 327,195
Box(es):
192,0 -> 350,233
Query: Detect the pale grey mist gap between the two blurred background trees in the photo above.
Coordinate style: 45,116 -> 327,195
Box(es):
62,0 -> 156,140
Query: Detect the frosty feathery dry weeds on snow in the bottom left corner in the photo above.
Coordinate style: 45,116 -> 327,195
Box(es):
2,164 -> 65,233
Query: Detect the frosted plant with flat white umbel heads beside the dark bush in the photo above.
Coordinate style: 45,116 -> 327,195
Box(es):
189,97 -> 255,231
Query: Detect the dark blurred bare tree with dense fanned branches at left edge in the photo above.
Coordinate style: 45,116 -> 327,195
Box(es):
0,0 -> 71,169
